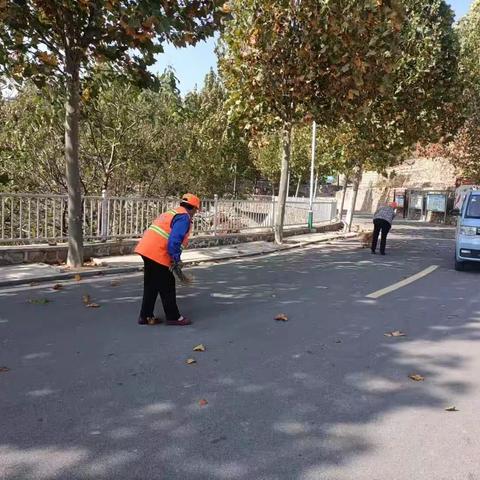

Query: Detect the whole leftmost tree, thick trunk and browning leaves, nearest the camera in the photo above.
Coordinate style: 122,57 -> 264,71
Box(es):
0,0 -> 227,266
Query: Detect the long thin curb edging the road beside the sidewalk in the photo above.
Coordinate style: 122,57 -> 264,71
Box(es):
0,233 -> 358,287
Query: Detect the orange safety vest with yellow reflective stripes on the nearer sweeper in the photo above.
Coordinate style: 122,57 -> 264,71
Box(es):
135,207 -> 192,267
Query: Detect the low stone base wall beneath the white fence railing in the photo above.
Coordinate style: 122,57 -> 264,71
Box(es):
0,223 -> 342,265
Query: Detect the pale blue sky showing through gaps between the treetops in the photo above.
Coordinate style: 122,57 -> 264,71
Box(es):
154,0 -> 473,93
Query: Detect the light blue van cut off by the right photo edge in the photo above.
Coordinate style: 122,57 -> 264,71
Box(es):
455,188 -> 480,271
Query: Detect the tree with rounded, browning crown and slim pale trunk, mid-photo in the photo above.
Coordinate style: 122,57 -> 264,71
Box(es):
220,0 -> 405,242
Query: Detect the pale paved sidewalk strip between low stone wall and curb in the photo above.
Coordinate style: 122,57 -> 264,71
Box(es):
0,231 -> 357,287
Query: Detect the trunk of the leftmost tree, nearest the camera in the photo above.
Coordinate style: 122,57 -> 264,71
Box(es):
65,51 -> 83,267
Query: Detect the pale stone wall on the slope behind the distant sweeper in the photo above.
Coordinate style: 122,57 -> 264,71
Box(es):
337,158 -> 456,213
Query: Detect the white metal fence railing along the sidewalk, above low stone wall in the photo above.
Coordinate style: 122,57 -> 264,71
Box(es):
0,193 -> 337,244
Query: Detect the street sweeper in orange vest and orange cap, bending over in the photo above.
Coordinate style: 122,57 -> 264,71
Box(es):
135,193 -> 200,326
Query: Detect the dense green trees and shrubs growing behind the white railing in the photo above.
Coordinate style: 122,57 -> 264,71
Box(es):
0,69 -> 257,197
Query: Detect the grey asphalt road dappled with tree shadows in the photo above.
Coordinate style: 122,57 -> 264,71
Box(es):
0,225 -> 480,480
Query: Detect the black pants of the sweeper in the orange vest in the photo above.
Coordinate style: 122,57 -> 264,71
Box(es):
140,256 -> 180,321
